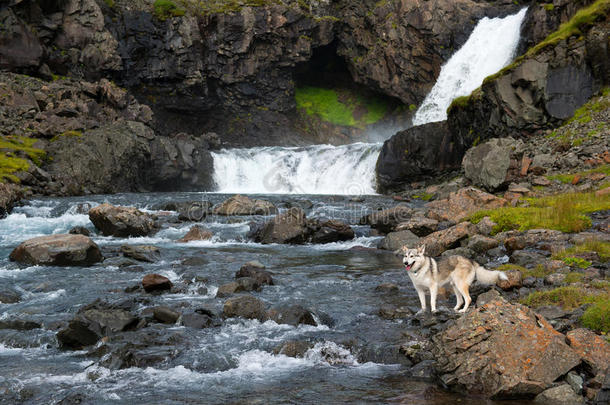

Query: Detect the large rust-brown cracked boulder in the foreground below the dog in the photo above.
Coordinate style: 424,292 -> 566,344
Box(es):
432,291 -> 580,398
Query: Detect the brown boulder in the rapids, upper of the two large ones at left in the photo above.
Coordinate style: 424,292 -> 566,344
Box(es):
89,204 -> 157,238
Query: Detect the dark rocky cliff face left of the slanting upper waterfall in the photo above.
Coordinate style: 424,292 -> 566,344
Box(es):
0,0 -> 518,194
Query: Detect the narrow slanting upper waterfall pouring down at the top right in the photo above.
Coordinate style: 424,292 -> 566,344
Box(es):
413,8 -> 527,125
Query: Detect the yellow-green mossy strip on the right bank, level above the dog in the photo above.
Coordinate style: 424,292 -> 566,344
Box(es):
470,192 -> 610,233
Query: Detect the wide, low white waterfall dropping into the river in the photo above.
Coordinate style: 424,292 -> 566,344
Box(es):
212,143 -> 381,194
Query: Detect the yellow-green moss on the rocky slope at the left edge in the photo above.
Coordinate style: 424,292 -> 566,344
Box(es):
0,135 -> 46,183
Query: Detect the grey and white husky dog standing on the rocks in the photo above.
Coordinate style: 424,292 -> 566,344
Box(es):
398,245 -> 508,312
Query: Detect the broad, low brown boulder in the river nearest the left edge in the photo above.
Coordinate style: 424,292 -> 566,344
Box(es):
9,234 -> 104,266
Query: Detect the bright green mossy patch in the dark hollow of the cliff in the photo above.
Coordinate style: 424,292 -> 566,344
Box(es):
295,86 -> 390,127
